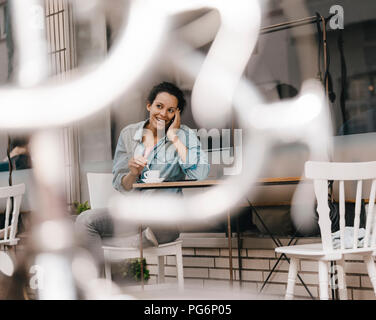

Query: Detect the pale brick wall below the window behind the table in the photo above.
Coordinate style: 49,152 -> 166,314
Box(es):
147,234 -> 375,300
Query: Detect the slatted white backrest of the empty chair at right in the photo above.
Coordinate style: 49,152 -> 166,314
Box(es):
305,161 -> 376,251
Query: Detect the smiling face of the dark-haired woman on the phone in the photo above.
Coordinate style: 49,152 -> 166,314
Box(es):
146,92 -> 178,131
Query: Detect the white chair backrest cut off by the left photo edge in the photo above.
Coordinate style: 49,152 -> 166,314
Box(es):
0,183 -> 25,241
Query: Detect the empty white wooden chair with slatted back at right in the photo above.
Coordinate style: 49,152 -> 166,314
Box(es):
275,161 -> 376,300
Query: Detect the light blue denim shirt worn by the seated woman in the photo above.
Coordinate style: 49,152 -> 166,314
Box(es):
112,120 -> 210,193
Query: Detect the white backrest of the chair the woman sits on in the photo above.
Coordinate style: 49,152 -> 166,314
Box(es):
87,172 -> 119,209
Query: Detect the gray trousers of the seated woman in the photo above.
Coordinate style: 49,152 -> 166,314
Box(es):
75,209 -> 179,266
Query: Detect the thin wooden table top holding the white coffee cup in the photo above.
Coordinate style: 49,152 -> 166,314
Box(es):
133,177 -> 305,189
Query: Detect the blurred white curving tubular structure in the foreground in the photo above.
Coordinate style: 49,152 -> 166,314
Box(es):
0,0 -> 331,299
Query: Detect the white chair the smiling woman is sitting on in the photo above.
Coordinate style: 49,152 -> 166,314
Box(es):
87,172 -> 184,289
